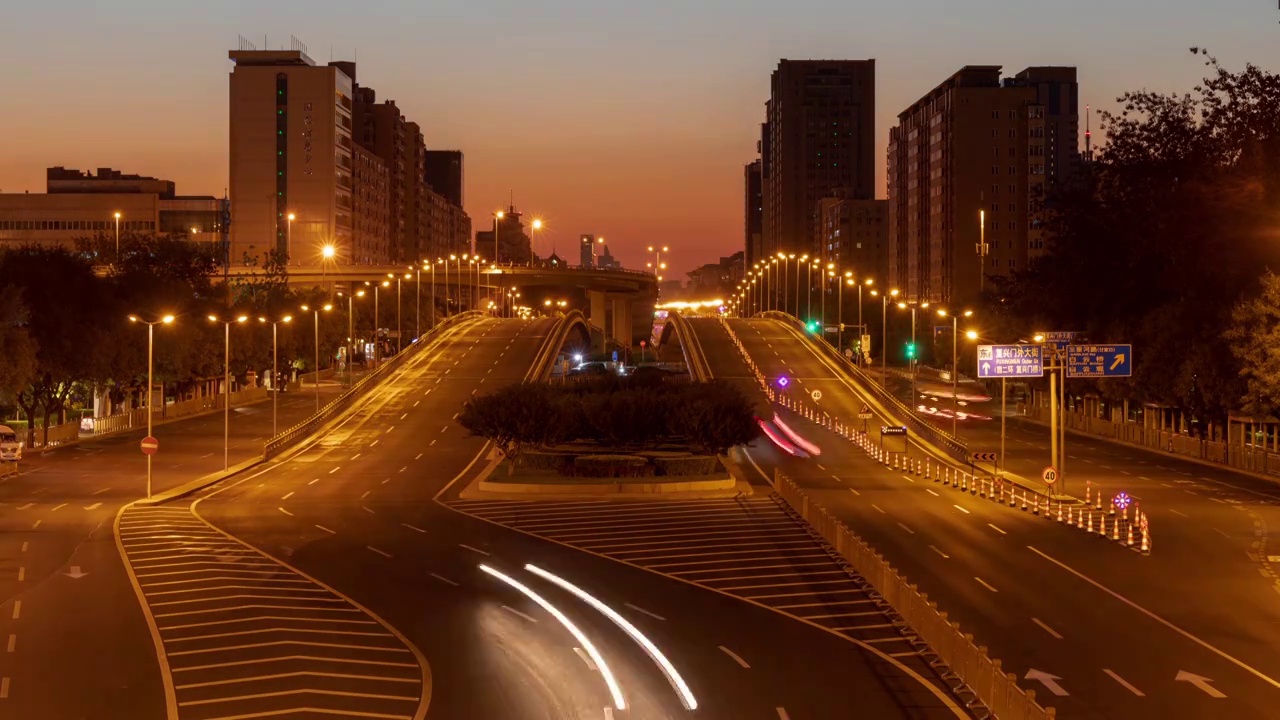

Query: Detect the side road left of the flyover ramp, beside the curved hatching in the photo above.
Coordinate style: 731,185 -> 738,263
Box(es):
0,366 -> 355,720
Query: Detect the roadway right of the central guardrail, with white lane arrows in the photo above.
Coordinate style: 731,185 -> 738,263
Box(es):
692,319 -> 1280,717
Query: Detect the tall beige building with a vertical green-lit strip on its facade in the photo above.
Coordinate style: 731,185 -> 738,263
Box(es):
228,50 -> 353,264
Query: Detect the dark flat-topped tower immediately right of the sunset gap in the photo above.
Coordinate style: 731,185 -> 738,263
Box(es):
753,60 -> 877,261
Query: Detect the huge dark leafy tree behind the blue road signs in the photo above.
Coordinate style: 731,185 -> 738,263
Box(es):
998,49 -> 1280,430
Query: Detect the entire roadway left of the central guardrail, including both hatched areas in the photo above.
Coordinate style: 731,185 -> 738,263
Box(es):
0,312 -> 964,720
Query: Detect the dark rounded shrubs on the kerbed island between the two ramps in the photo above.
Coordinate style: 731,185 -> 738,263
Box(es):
458,377 -> 756,482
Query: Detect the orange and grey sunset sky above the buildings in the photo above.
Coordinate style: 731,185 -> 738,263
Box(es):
0,0 -> 1280,278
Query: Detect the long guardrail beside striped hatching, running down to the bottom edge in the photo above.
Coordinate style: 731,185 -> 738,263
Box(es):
774,473 -> 1057,720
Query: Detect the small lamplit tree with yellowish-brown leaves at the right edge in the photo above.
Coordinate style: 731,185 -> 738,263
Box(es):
1225,272 -> 1280,418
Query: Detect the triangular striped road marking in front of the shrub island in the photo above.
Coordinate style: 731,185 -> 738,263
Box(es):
448,496 -> 908,644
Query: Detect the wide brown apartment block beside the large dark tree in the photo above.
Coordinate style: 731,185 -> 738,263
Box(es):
888,65 -> 1080,302
